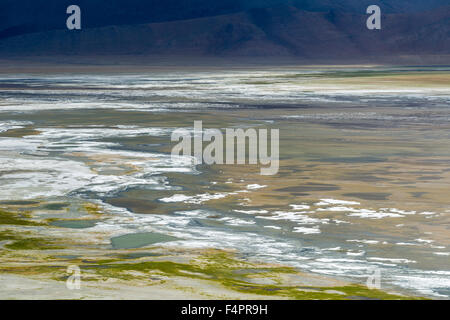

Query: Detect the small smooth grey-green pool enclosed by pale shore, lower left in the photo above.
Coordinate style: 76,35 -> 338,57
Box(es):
111,232 -> 180,249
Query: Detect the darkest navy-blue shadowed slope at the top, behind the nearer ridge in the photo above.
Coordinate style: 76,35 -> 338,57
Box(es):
0,0 -> 449,39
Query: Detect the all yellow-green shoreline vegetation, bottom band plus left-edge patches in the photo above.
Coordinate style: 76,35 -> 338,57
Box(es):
0,208 -> 421,300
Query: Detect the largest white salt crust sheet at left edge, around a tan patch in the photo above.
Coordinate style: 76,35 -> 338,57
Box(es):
0,126 -> 195,200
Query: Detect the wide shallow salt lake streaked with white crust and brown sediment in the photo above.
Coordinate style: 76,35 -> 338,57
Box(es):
0,68 -> 450,298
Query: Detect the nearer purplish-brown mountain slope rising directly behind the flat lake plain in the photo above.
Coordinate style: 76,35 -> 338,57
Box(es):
0,5 -> 450,59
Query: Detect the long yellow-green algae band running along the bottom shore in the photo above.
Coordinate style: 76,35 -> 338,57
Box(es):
0,246 -> 419,300
